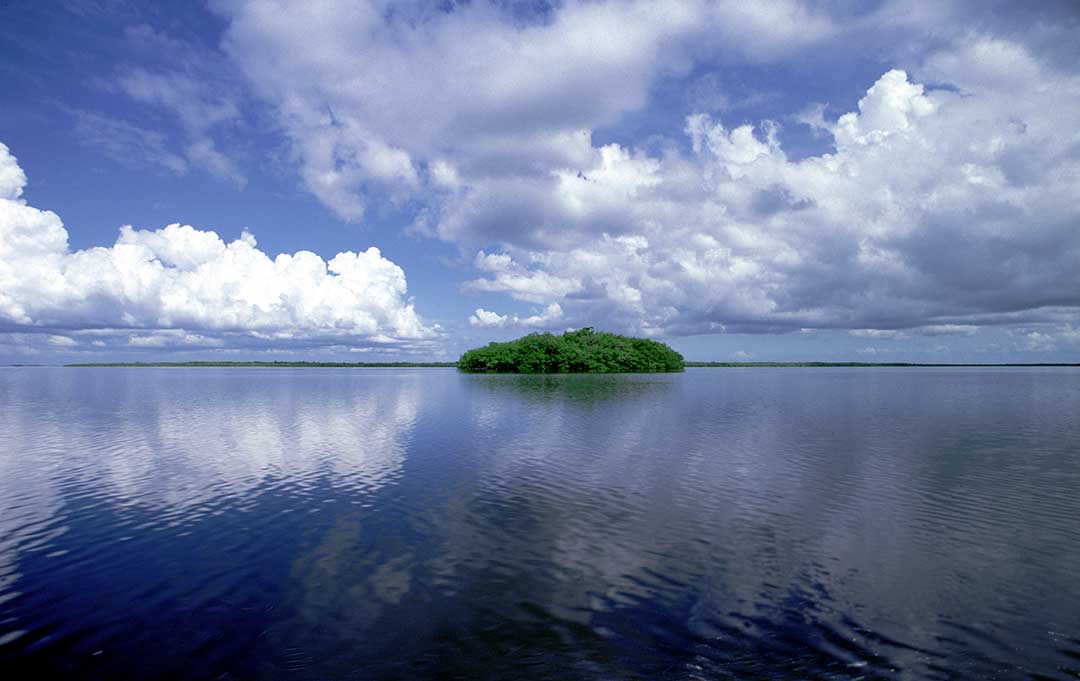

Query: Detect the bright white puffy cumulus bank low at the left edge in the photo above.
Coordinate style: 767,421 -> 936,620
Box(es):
0,144 -> 436,348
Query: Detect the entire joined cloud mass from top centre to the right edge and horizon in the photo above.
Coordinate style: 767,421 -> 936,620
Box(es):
208,1 -> 1080,336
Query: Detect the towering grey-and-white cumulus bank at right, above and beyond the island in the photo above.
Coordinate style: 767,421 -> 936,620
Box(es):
460,45 -> 1080,338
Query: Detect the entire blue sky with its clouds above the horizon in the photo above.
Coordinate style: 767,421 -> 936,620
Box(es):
0,0 -> 1080,364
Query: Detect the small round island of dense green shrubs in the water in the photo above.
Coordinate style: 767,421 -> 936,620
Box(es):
458,328 -> 683,373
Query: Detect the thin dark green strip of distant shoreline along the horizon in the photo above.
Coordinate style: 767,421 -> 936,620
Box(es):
48,362 -> 1080,369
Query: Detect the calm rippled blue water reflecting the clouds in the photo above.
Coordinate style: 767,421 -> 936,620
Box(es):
0,368 -> 1080,680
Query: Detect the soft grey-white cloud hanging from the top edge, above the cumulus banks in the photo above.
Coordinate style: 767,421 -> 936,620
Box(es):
214,0 -> 833,222
